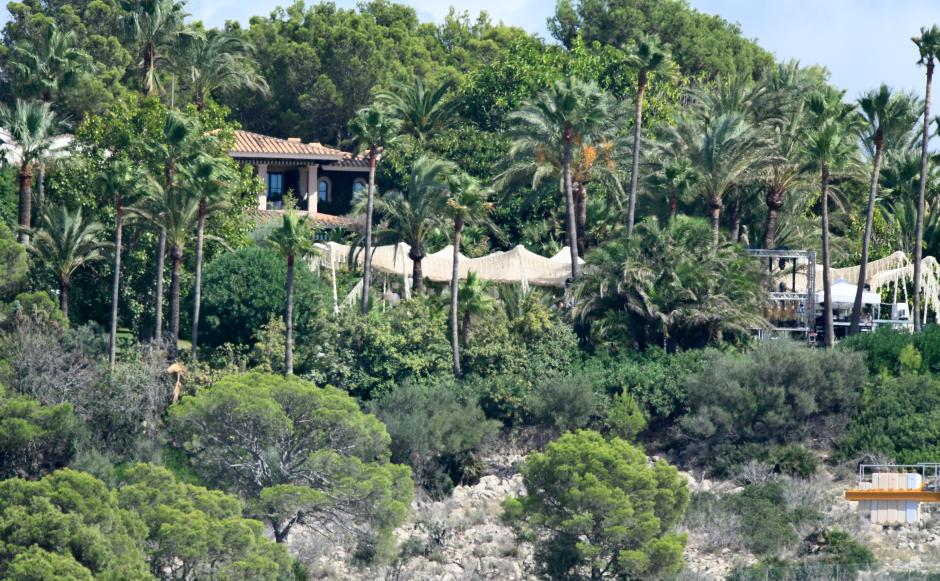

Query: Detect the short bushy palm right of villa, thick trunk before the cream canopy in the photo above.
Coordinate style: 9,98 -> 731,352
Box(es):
375,156 -> 453,293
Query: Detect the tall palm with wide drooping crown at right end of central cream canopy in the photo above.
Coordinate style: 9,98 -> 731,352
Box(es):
509,77 -> 611,280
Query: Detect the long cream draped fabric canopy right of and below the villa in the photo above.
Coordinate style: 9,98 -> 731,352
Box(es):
321,242 -> 571,288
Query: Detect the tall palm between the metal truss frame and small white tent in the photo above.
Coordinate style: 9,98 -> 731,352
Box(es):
804,89 -> 857,347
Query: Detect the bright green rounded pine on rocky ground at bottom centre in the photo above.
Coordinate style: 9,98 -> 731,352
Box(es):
504,430 -> 689,579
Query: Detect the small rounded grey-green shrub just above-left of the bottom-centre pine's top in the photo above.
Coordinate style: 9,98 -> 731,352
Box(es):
526,374 -> 605,432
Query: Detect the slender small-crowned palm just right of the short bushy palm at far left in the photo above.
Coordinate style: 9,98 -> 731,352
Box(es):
100,160 -> 147,373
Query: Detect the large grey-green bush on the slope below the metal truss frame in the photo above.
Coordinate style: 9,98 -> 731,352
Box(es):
678,342 -> 866,473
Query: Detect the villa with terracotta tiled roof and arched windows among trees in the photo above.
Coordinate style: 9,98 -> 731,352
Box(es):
230,130 -> 369,226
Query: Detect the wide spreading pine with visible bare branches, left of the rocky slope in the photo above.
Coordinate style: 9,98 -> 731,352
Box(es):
170,373 -> 413,550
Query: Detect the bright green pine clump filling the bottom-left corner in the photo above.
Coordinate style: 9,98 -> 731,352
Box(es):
0,464 -> 292,581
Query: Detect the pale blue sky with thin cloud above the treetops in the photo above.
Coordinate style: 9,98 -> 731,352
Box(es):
0,0 -> 940,105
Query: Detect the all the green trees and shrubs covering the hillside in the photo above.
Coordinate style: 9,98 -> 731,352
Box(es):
0,0 -> 940,580
